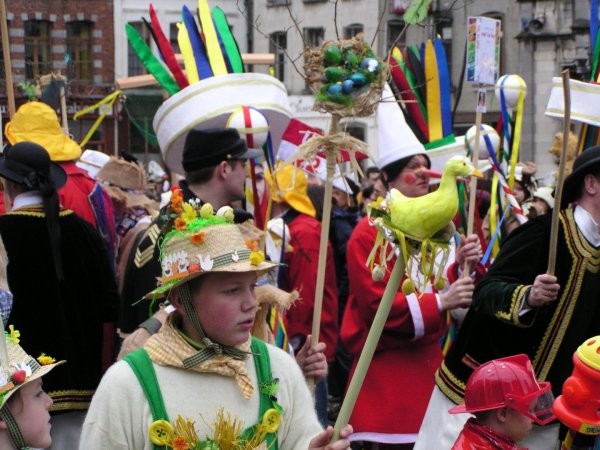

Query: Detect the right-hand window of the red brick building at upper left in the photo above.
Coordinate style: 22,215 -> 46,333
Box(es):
67,20 -> 94,80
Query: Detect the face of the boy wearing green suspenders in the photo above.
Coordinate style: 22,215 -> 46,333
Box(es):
180,272 -> 258,346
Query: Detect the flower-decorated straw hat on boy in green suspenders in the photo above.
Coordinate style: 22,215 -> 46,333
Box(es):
146,189 -> 275,299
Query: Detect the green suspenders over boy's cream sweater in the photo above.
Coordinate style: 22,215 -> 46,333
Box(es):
123,337 -> 277,450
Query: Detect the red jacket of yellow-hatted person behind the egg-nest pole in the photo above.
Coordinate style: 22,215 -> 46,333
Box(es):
281,214 -> 339,362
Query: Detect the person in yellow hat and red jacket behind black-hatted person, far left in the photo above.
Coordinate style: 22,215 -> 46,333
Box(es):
4,102 -> 117,264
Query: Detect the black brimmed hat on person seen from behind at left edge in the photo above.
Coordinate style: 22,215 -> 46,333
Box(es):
0,141 -> 67,189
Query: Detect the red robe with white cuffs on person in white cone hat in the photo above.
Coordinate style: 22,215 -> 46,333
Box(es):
340,218 -> 446,443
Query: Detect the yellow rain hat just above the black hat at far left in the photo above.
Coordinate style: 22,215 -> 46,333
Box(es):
4,102 -> 81,161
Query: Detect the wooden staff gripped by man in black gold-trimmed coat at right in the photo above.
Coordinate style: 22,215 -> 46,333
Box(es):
546,69 -> 571,275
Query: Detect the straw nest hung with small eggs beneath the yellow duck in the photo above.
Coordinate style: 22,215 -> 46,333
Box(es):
366,197 -> 455,295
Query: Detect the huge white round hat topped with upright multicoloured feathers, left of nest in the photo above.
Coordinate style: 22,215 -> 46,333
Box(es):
125,0 -> 292,174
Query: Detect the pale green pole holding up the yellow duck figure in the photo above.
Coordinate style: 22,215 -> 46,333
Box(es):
332,254 -> 405,442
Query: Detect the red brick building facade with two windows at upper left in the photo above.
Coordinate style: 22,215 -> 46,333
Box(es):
0,0 -> 114,151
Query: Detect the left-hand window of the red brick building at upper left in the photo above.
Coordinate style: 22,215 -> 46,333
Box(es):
24,19 -> 52,80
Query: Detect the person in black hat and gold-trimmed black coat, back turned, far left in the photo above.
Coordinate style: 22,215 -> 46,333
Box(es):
0,142 -> 119,448
